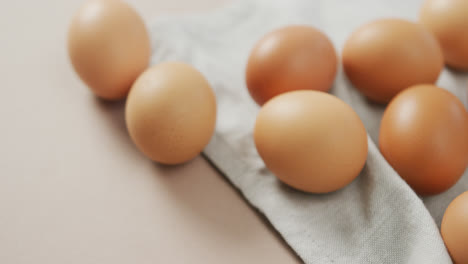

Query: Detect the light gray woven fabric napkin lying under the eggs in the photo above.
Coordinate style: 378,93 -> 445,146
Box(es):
150,0 -> 468,264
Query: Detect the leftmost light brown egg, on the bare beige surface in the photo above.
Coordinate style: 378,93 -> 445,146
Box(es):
68,0 -> 150,100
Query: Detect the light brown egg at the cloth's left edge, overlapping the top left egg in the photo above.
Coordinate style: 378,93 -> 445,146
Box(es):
125,62 -> 216,164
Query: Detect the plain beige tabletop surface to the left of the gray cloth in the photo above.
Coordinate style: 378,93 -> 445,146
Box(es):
0,0 -> 300,264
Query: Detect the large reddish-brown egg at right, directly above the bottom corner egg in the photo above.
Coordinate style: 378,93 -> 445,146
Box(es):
379,85 -> 468,195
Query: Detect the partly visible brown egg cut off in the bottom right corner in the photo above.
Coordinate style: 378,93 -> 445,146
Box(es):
440,192 -> 468,264
